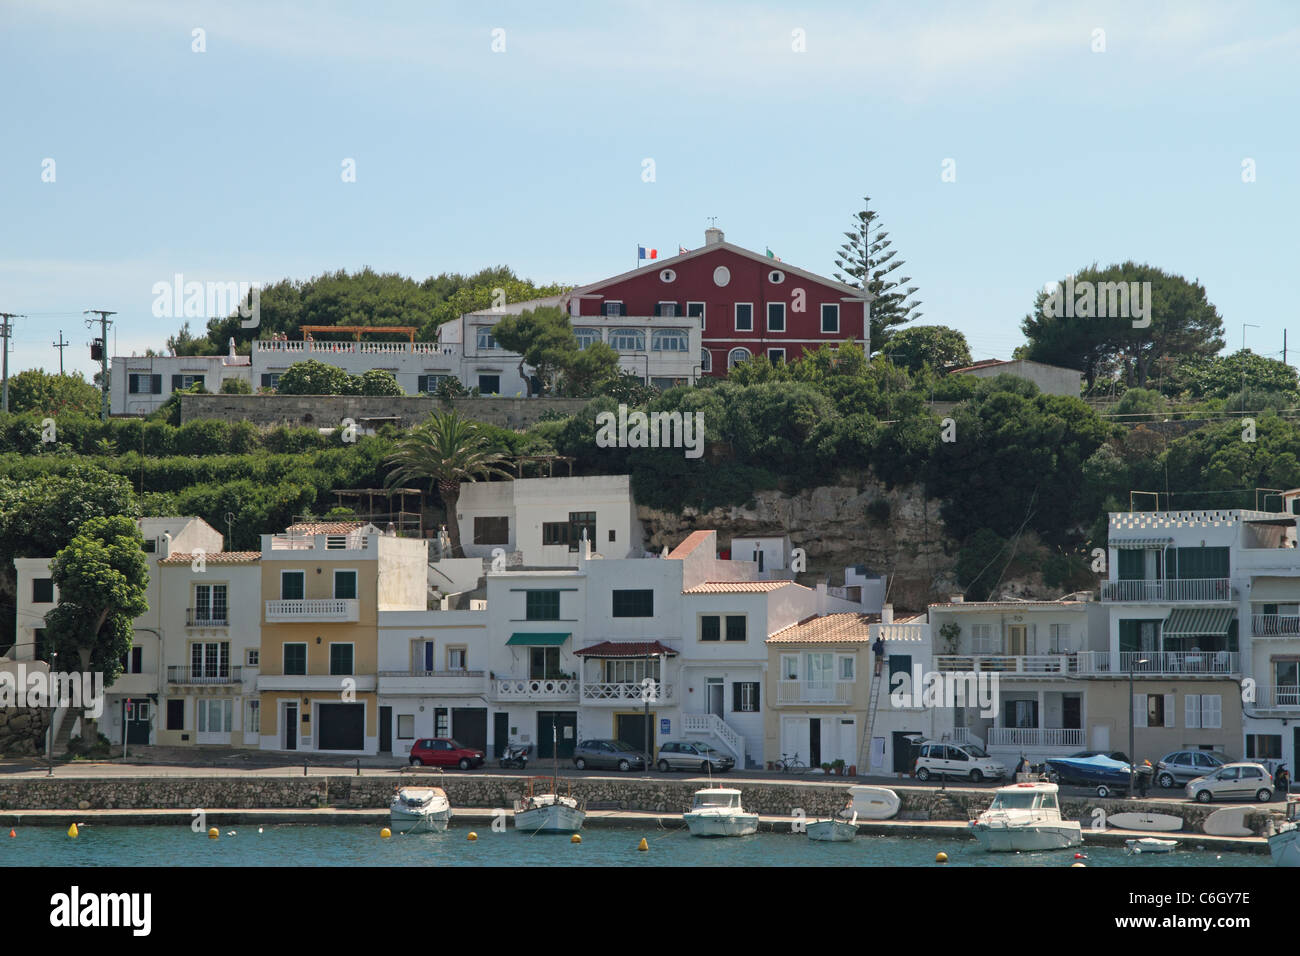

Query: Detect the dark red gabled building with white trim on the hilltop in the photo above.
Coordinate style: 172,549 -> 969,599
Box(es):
569,229 -> 872,376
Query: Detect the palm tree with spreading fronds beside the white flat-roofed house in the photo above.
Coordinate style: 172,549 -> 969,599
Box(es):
385,411 -> 512,555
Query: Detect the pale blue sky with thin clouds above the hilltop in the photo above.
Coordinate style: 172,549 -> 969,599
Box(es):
0,0 -> 1300,382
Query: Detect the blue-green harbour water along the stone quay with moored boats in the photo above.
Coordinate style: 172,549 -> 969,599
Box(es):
0,821 -> 1269,868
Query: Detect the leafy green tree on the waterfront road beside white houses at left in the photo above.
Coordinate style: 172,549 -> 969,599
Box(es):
46,515 -> 150,743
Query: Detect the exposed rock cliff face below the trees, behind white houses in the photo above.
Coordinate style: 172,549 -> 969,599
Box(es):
638,479 -> 961,610
